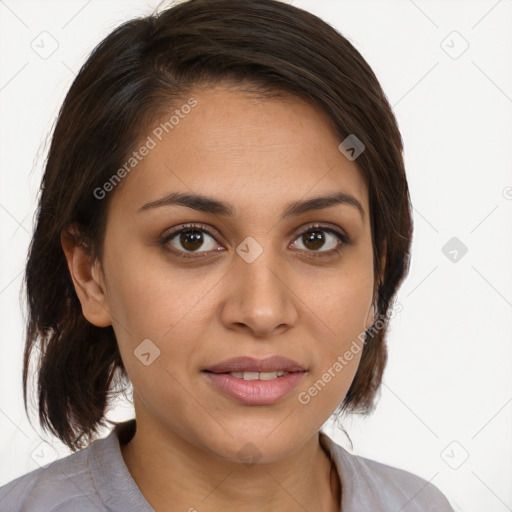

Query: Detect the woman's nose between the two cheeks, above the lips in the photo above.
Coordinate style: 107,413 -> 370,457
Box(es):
221,250 -> 300,338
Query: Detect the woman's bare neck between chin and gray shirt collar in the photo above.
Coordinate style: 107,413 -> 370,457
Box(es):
121,412 -> 341,512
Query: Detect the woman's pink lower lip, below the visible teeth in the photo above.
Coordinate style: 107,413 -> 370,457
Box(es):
203,370 -> 307,405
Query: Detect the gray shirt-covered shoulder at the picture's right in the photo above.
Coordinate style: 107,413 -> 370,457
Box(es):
322,432 -> 453,512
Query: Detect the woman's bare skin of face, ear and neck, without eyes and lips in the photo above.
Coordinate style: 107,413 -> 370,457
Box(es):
62,85 -> 384,512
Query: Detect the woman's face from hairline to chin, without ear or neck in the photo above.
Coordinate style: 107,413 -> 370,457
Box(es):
96,86 -> 374,462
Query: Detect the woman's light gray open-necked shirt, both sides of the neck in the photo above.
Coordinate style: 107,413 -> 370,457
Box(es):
0,419 -> 453,512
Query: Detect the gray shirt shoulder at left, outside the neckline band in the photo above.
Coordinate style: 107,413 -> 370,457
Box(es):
0,447 -> 106,512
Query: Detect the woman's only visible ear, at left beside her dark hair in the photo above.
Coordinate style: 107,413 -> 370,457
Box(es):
60,228 -> 112,327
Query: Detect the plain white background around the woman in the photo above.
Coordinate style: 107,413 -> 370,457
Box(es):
0,0 -> 512,512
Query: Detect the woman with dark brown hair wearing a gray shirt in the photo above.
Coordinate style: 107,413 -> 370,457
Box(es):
0,0 -> 452,512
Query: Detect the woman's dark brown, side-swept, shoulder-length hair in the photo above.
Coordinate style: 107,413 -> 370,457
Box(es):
23,0 -> 412,450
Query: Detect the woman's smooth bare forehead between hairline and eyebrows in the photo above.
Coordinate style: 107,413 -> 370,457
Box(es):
107,85 -> 368,215
